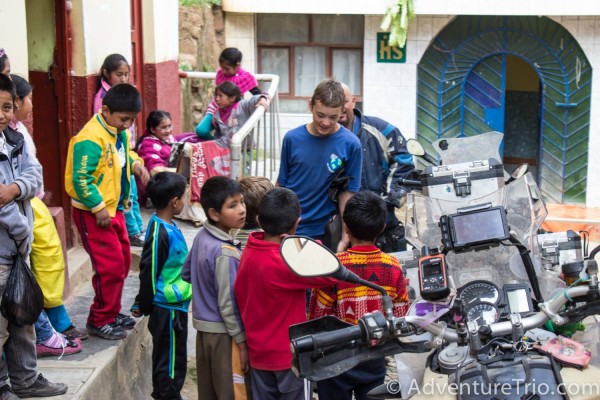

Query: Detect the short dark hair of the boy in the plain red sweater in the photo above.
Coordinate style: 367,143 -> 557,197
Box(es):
258,187 -> 300,236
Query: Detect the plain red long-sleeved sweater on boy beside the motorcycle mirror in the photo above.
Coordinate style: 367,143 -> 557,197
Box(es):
234,232 -> 338,371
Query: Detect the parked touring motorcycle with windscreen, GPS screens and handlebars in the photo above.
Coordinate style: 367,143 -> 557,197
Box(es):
281,134 -> 600,400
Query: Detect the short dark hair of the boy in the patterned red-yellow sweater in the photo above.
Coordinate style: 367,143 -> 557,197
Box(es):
343,190 -> 387,241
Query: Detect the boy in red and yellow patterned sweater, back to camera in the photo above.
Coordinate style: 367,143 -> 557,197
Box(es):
309,191 -> 408,400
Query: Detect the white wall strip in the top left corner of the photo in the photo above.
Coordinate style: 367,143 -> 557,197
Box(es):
0,0 -> 29,77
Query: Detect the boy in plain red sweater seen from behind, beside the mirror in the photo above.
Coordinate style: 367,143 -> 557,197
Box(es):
234,188 -> 337,400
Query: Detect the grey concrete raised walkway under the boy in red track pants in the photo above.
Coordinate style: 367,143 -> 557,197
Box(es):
47,209 -> 202,400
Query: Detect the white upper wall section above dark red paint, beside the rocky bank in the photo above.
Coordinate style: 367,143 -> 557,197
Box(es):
142,0 -> 179,64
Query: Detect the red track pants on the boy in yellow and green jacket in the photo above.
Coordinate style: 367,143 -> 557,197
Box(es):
73,208 -> 131,327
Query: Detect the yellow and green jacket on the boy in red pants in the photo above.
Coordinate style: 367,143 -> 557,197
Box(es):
65,113 -> 144,217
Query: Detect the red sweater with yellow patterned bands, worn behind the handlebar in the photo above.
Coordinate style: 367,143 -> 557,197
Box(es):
309,246 -> 408,325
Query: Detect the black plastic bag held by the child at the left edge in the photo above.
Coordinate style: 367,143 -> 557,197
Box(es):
0,254 -> 44,327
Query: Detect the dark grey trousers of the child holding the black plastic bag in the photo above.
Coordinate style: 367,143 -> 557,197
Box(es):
0,265 -> 38,389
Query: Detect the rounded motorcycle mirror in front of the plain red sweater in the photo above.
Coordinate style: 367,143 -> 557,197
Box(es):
280,236 -> 340,278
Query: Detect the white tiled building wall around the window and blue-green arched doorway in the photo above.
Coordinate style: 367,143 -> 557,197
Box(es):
224,12 -> 600,207
